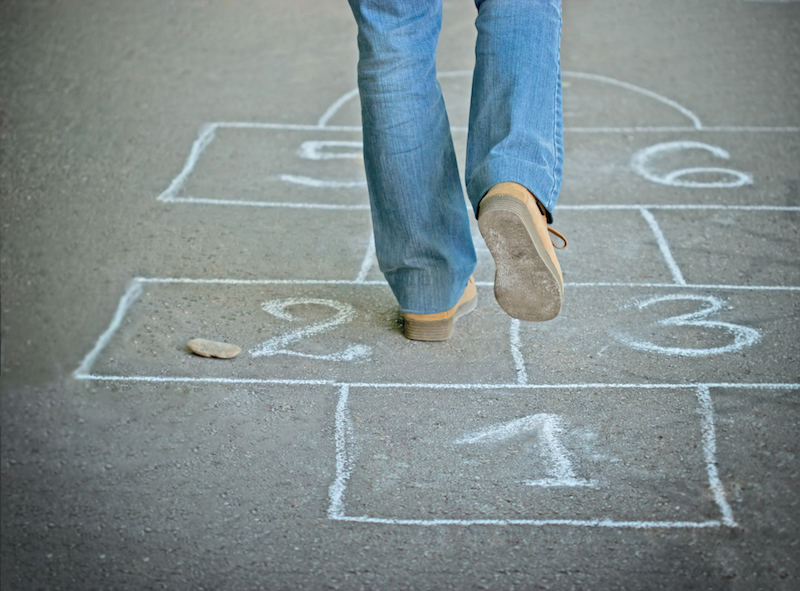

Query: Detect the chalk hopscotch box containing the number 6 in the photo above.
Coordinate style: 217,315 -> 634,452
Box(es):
556,132 -> 800,208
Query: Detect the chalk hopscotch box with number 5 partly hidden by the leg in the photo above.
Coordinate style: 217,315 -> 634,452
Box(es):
169,123 -> 368,208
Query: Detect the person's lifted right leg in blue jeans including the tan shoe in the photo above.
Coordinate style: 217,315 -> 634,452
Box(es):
466,0 -> 564,320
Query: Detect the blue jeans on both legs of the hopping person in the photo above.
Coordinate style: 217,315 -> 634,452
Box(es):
349,0 -> 564,314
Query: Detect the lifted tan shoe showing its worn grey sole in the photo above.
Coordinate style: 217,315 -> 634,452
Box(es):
478,183 -> 567,321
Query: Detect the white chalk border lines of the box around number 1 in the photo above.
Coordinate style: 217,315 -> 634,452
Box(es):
328,383 -> 764,529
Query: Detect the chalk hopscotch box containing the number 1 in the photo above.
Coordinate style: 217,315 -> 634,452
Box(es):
330,387 -> 722,527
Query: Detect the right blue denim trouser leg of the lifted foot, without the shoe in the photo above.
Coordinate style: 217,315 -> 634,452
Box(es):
466,0 -> 564,221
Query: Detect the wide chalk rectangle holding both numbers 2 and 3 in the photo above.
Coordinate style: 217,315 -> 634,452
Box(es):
73,279 -> 800,385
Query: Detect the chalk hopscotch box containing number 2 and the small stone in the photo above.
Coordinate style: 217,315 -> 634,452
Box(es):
84,280 -> 515,383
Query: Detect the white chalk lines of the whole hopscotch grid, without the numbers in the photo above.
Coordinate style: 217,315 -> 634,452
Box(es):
73,72 -> 800,528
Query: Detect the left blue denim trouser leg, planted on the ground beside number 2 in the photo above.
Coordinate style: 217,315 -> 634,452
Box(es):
350,0 -> 476,314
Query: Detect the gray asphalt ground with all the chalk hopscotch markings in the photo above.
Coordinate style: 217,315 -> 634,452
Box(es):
0,0 -> 800,591
